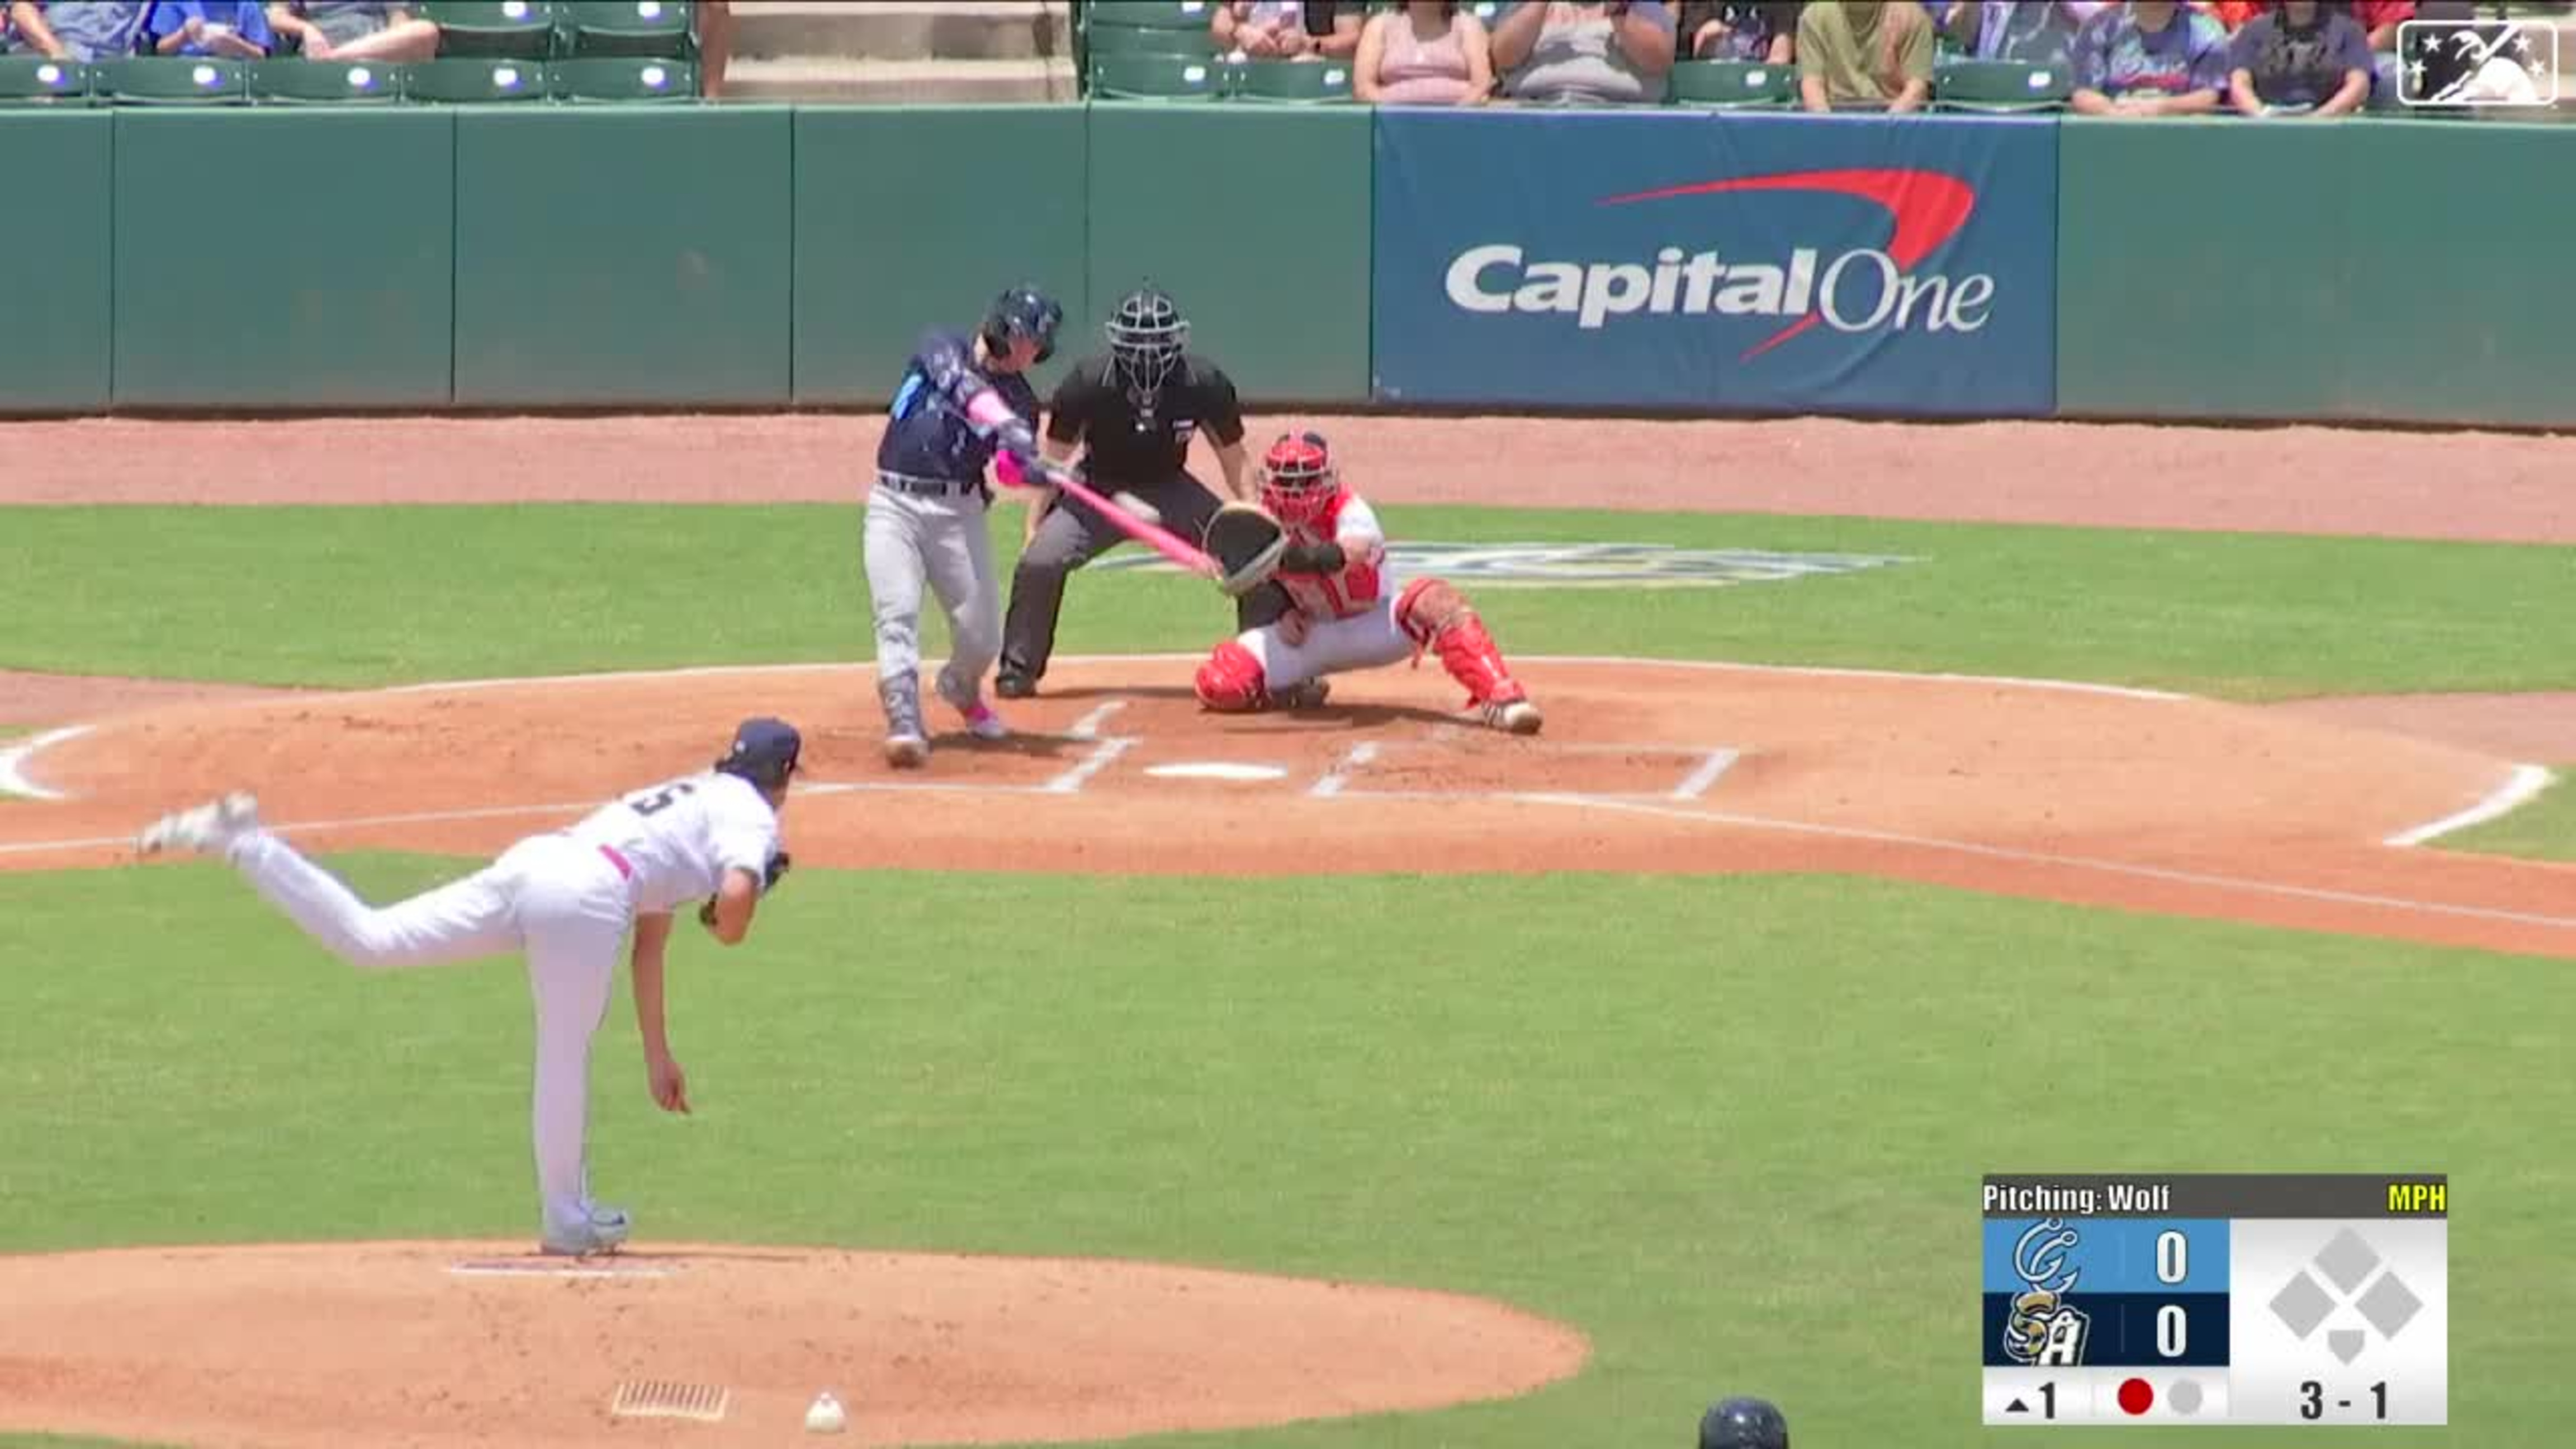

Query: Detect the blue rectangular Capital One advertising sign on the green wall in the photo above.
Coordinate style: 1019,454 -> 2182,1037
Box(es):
1370,108 -> 2058,415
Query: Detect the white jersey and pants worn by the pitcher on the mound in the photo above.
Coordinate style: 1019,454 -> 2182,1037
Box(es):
190,771 -> 778,1243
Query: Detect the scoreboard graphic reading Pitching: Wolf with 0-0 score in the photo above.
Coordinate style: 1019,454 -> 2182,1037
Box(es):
1978,1173 -> 2450,1426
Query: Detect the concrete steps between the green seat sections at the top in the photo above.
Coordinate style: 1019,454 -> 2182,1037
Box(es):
724,0 -> 1082,106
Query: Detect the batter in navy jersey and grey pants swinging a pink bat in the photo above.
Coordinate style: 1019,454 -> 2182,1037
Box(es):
865,286 -> 1064,768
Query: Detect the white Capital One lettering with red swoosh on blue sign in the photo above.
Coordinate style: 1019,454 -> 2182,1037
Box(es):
1442,168 -> 1994,361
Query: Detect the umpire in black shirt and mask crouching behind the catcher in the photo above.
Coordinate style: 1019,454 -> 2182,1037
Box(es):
995,286 -> 1252,699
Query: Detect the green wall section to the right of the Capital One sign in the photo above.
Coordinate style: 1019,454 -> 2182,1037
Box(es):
2056,119 -> 2576,425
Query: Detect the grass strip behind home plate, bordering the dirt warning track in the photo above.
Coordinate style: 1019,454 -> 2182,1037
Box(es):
0,505 -> 2576,699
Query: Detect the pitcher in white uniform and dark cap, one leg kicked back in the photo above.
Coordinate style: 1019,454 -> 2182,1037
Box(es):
139,719 -> 804,1256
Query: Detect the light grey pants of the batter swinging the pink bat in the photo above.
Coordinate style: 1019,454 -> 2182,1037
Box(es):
865,485 -> 1002,717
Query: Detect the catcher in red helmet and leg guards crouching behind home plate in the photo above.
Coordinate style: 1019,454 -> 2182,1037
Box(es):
1198,433 -> 1538,735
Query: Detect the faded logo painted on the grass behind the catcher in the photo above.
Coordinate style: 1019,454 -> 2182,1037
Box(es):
1090,544 -> 1911,588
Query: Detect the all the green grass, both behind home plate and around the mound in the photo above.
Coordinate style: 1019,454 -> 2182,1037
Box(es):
0,508 -> 2576,1449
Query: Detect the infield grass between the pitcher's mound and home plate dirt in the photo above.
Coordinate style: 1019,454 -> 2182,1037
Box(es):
0,856 -> 2576,1449
